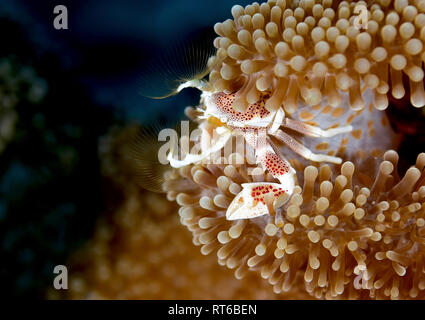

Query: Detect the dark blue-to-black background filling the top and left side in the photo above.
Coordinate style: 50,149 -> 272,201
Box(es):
0,0 -> 250,299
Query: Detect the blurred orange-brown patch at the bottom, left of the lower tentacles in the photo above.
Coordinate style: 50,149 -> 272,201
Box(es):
54,189 -> 308,299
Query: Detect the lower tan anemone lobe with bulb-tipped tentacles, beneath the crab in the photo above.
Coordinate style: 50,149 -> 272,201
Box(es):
164,151 -> 425,299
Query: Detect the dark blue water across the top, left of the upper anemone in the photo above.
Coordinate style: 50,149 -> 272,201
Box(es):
0,0 -> 251,123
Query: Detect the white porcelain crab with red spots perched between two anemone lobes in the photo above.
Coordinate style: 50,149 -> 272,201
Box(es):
168,92 -> 352,220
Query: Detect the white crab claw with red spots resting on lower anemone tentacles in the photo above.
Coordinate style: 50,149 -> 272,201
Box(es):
226,182 -> 293,220
